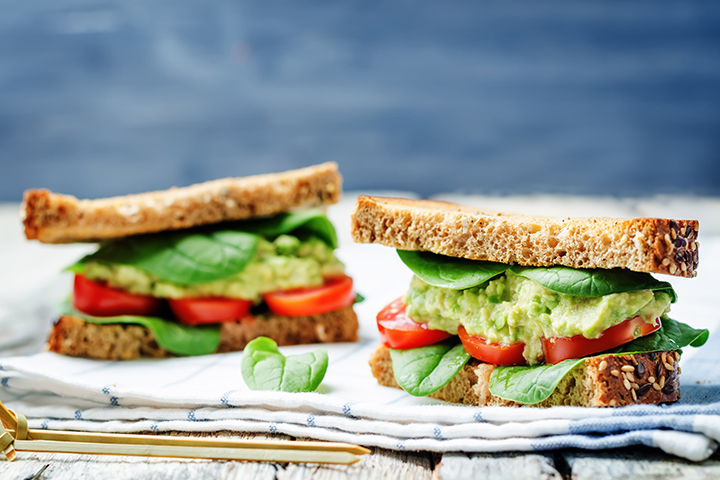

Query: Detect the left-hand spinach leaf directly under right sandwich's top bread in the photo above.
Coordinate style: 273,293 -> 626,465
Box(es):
397,250 -> 510,290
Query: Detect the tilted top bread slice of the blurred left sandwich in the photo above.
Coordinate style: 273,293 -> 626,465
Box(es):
21,162 -> 342,243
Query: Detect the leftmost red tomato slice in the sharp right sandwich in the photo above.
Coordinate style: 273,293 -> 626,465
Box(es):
377,298 -> 452,350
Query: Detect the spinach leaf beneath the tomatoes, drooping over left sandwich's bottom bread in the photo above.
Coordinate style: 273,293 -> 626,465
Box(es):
63,304 -> 220,355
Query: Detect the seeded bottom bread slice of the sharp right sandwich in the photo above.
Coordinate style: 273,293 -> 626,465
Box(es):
370,345 -> 680,407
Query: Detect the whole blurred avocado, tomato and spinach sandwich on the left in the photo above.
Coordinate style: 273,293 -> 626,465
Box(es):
21,163 -> 358,360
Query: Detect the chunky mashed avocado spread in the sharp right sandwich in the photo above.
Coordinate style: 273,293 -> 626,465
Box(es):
405,271 -> 672,364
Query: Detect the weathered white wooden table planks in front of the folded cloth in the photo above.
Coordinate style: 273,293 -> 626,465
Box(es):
0,433 -> 720,480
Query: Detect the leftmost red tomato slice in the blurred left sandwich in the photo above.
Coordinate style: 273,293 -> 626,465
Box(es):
73,275 -> 163,317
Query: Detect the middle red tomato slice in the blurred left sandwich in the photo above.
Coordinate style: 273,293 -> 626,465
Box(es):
168,297 -> 252,325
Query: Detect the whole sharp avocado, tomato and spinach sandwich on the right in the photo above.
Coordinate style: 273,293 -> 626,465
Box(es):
352,197 -> 708,407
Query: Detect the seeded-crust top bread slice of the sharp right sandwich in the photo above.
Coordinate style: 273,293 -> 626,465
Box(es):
352,196 -> 698,277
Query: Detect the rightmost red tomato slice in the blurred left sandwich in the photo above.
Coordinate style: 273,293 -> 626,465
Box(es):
263,275 -> 355,317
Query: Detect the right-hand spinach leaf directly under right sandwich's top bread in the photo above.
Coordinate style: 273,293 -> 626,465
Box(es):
512,265 -> 677,303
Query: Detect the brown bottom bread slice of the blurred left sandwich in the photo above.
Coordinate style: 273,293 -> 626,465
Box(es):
47,306 -> 358,360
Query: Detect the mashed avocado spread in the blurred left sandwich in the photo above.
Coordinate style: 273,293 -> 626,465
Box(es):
84,235 -> 344,302
